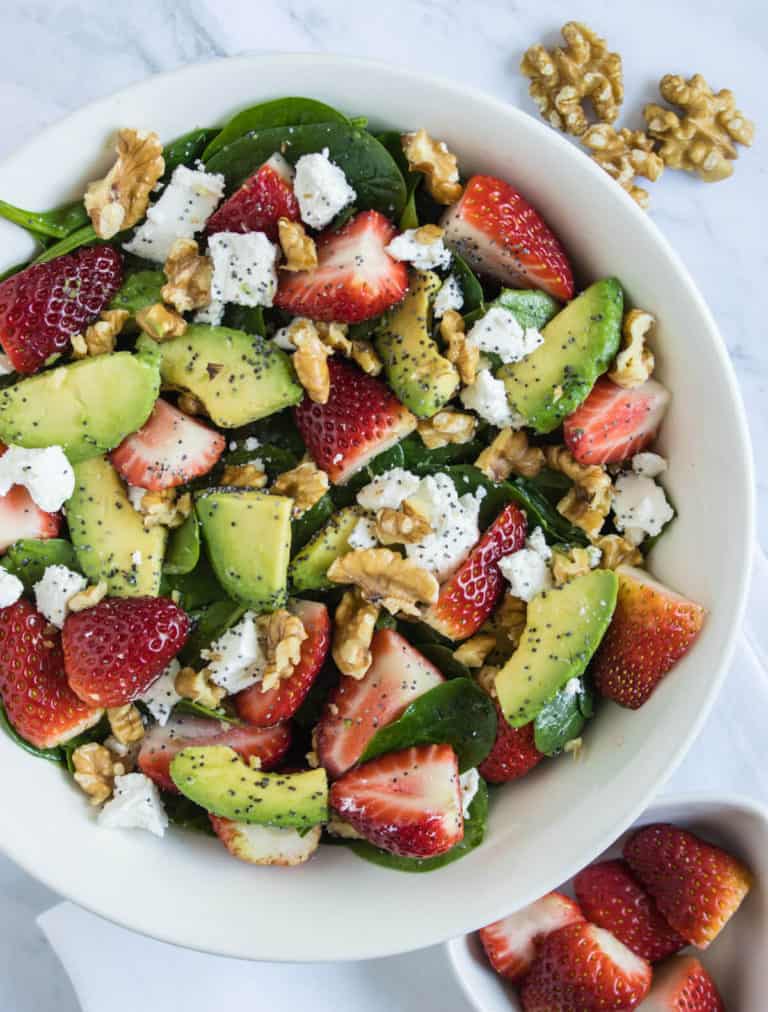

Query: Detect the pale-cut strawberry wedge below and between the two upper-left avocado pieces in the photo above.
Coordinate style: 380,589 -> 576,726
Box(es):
109,400 -> 227,489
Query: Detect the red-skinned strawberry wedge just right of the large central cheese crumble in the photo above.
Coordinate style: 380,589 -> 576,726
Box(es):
424,503 -> 526,640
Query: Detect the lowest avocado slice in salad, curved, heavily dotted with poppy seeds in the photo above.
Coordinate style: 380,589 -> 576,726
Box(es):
171,745 -> 328,829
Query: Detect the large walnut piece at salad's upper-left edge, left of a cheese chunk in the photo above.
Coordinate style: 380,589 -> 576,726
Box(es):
85,130 -> 165,239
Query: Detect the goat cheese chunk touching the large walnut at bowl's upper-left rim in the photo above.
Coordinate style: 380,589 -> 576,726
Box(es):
122,165 -> 225,263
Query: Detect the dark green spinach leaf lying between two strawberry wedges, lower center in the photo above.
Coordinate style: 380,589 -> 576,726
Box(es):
360,678 -> 496,772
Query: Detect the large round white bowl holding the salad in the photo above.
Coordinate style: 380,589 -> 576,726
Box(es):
0,54 -> 753,959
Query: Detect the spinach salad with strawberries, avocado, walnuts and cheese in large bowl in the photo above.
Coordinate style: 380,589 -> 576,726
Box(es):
0,97 -> 704,871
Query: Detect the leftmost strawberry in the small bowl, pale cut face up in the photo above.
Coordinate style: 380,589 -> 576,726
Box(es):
480,893 -> 584,981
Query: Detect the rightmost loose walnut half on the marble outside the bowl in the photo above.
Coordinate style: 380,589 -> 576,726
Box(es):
643,74 -> 755,183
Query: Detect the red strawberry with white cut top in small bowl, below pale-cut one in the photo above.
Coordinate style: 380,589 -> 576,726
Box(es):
521,923 -> 651,1012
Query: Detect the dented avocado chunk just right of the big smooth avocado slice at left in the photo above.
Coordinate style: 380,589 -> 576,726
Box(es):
139,325 -> 304,429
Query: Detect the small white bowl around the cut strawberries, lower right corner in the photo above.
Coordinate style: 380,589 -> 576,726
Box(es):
446,794 -> 768,1012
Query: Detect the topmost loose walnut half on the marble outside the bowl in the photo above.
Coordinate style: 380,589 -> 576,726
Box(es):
520,21 -> 624,137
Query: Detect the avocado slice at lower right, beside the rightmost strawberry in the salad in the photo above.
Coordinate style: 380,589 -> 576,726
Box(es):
496,570 -> 618,728
